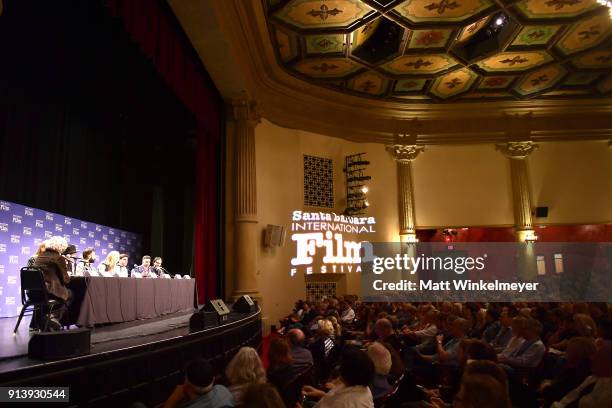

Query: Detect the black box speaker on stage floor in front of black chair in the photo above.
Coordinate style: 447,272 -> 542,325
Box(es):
28,329 -> 91,360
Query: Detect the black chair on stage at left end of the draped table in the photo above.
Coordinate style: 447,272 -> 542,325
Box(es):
13,266 -> 64,333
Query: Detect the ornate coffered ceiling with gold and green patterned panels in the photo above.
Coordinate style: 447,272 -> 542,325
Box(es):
261,0 -> 612,104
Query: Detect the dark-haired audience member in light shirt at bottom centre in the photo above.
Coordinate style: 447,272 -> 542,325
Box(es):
304,349 -> 374,408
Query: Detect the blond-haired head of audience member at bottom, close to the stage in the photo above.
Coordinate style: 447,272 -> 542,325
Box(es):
225,347 -> 266,405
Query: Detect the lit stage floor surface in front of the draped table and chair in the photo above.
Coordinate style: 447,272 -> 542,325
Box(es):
0,311 -> 193,373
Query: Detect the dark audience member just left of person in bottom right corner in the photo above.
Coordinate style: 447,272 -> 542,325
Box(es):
540,337 -> 596,406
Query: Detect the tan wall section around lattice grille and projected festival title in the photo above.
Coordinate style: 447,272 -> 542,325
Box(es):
255,120 -> 398,324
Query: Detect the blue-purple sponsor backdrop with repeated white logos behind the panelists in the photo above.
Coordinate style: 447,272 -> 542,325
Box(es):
0,200 -> 142,317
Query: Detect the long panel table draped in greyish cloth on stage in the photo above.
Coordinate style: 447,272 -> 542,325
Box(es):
68,277 -> 197,326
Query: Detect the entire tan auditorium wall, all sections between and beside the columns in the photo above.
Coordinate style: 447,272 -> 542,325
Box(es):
226,120 -> 612,325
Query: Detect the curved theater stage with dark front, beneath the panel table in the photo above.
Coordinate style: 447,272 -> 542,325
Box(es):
0,311 -> 261,407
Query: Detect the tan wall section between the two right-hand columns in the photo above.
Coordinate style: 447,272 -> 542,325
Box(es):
412,145 -> 514,228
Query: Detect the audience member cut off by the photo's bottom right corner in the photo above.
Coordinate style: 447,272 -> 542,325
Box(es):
551,346 -> 612,408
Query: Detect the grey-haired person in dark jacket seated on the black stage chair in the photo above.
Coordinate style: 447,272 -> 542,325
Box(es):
34,237 -> 72,330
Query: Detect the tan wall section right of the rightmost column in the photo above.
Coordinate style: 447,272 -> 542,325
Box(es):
528,141 -> 612,224
